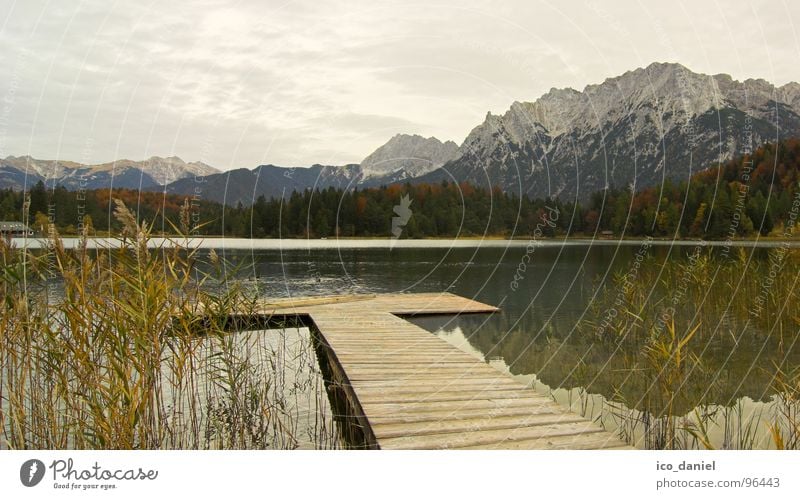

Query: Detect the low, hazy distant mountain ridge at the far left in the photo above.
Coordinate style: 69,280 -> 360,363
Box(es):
0,156 -> 219,190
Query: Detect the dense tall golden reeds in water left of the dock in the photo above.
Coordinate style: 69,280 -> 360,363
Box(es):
0,202 -> 339,449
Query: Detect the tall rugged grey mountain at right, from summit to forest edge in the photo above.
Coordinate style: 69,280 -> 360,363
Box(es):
416,63 -> 800,199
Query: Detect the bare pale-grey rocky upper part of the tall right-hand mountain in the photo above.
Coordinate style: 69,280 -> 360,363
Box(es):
461,62 -> 800,153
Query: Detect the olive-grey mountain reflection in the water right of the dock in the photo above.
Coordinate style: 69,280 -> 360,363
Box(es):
421,294 -> 800,414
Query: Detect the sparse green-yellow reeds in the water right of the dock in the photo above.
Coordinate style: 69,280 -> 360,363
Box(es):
581,246 -> 800,449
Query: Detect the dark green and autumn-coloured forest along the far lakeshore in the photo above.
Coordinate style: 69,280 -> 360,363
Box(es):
0,139 -> 800,240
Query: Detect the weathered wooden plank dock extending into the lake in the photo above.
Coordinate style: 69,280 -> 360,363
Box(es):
266,293 -> 626,449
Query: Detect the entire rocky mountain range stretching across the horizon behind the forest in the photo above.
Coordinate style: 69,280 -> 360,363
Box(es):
6,63 -> 800,205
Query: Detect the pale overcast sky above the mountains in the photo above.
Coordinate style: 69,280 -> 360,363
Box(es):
0,0 -> 800,169
